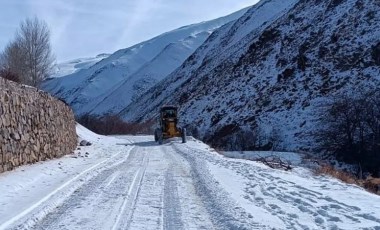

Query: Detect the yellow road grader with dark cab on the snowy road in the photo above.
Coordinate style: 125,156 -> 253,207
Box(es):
154,106 -> 186,145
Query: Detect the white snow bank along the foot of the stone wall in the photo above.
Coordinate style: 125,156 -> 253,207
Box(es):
0,125 -> 131,230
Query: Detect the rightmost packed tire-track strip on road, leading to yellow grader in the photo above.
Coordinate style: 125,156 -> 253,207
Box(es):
161,142 -> 215,230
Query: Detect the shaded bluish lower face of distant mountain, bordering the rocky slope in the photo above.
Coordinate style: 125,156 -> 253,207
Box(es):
84,31 -> 211,114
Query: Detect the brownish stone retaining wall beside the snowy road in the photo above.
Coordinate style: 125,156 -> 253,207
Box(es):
0,78 -> 77,172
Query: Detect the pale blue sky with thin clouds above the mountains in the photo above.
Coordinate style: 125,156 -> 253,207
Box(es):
0,0 -> 258,62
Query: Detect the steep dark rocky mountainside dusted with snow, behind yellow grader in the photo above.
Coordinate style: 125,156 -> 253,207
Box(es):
120,0 -> 380,148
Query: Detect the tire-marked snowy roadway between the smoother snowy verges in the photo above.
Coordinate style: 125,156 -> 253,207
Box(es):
30,137 -> 217,229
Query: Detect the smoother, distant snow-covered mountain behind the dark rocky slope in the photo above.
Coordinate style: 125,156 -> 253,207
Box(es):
43,9 -> 248,115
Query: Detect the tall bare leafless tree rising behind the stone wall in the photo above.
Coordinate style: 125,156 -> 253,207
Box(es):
0,17 -> 55,87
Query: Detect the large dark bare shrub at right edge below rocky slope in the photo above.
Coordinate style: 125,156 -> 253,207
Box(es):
315,89 -> 380,176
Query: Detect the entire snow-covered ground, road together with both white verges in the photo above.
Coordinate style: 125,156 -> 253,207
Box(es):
0,126 -> 380,230
